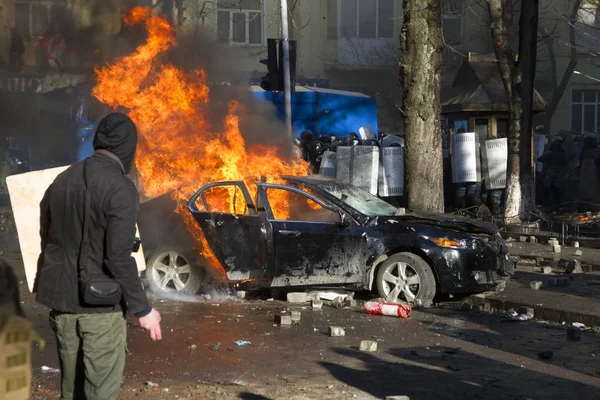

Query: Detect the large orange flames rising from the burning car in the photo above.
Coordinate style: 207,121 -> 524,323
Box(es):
92,7 -> 307,278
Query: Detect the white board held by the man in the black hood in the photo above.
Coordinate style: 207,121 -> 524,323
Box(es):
6,166 -> 146,292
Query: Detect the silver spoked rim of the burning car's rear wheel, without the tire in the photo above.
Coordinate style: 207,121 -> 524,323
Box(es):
151,251 -> 192,292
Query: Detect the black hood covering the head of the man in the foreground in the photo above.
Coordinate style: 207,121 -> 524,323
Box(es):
94,113 -> 137,174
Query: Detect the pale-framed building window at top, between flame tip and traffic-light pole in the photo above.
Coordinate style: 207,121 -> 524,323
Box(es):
217,0 -> 265,45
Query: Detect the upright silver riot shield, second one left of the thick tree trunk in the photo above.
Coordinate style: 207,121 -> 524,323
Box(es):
350,146 -> 379,195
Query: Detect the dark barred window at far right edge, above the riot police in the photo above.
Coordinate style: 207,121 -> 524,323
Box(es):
571,89 -> 600,133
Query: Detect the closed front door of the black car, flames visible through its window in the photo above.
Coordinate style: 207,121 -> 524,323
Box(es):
258,183 -> 368,287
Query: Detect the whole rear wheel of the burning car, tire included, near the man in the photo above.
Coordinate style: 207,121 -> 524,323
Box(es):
146,247 -> 207,294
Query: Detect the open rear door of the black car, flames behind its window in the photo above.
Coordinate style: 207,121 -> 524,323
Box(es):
189,181 -> 266,281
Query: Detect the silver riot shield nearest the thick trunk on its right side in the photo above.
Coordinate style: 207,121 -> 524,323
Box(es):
452,132 -> 481,183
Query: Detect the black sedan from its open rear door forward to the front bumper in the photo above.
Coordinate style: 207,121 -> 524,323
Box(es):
189,175 -> 513,303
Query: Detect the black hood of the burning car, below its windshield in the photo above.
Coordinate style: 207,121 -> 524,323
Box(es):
377,211 -> 498,235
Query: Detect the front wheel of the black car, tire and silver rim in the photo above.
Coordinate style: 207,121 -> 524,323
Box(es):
376,253 -> 436,307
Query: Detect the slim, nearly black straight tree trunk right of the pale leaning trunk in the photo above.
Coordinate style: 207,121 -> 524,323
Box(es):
518,0 -> 539,219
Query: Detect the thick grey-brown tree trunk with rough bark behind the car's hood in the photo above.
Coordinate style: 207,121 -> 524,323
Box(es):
400,0 -> 444,212
